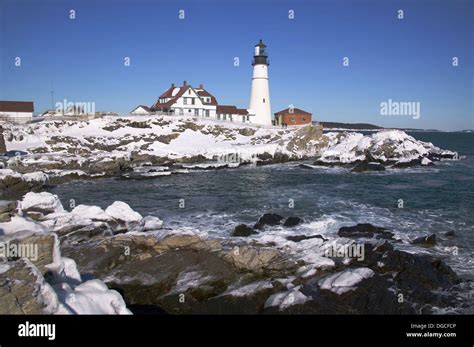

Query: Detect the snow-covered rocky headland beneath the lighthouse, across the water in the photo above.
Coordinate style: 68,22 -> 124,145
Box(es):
0,116 -> 458,199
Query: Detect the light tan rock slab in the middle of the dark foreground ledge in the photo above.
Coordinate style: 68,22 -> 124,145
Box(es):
224,246 -> 296,272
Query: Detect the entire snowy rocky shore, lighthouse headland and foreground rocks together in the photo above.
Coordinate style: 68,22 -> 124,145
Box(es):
0,117 -> 466,314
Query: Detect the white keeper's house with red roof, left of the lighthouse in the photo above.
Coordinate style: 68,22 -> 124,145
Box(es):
131,81 -> 254,123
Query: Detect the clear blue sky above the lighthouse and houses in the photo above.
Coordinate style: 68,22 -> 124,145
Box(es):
0,0 -> 474,130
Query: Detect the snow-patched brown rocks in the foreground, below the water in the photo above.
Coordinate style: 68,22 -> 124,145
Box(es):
0,192 -> 471,314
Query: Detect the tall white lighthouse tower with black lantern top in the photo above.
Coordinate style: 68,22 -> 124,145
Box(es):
249,40 -> 272,125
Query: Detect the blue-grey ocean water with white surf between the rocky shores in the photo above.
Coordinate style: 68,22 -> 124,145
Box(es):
50,132 -> 474,279
